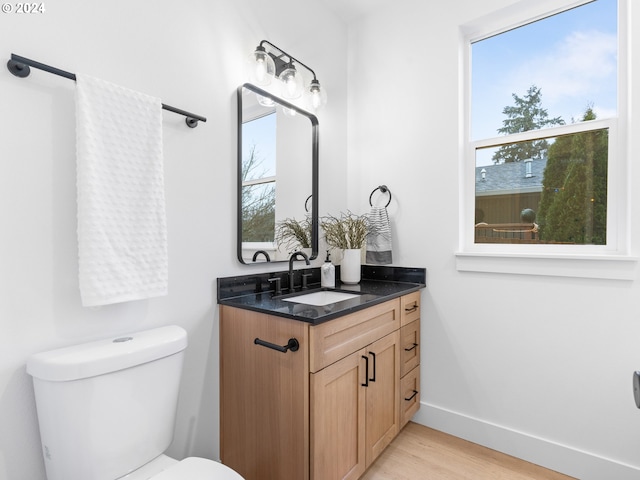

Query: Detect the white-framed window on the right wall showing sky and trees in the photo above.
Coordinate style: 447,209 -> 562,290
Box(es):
459,0 -> 628,280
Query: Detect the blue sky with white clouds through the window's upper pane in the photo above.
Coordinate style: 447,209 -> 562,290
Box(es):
471,0 -> 617,144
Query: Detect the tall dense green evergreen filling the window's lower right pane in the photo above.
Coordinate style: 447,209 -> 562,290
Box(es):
537,107 -> 609,245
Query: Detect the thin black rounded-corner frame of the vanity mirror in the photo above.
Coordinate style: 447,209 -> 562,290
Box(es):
236,83 -> 319,265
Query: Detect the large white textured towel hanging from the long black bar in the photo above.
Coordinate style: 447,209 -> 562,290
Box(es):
76,75 -> 168,306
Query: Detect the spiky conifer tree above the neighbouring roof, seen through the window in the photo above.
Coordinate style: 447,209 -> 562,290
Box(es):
491,85 -> 564,164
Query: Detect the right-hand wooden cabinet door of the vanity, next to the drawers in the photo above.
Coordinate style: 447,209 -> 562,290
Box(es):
366,330 -> 400,466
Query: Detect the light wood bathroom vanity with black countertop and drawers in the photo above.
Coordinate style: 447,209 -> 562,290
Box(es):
219,269 -> 425,480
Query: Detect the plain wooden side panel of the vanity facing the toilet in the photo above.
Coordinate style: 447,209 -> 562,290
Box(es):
220,306 -> 309,480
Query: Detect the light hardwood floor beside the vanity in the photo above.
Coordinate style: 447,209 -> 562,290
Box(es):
361,422 -> 572,480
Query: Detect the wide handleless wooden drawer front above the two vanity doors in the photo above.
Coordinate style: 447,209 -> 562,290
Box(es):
309,299 -> 400,372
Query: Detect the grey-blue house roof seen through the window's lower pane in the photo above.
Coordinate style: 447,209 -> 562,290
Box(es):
476,158 -> 547,196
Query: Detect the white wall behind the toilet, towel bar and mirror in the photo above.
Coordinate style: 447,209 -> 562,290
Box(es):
0,0 -> 347,480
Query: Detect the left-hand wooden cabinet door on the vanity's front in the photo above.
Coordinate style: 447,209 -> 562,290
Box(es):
310,349 -> 368,480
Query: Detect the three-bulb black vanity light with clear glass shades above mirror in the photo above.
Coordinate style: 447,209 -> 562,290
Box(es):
249,40 -> 327,111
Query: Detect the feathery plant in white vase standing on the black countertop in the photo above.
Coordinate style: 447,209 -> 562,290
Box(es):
320,211 -> 369,284
